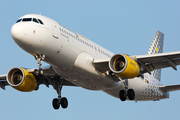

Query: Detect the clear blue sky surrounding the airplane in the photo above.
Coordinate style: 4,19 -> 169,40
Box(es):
0,0 -> 180,120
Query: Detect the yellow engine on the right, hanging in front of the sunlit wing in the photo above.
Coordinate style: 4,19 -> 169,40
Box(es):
109,54 -> 140,78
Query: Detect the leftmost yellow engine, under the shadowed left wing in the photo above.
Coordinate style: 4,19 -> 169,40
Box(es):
7,68 -> 37,92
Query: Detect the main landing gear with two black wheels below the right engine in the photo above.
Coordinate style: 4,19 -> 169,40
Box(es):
119,79 -> 135,101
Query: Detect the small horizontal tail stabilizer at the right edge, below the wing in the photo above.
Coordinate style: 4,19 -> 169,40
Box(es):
159,85 -> 180,92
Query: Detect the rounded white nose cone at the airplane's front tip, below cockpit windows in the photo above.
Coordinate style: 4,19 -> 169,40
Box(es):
11,24 -> 25,43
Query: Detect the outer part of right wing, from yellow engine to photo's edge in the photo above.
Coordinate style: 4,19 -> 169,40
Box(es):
132,51 -> 180,73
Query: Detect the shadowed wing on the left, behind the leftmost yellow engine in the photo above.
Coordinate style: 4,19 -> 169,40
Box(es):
0,66 -> 76,90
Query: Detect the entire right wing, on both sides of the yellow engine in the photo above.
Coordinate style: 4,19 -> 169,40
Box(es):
93,51 -> 180,74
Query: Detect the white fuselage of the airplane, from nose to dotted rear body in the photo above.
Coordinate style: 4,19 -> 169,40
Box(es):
11,14 -> 169,101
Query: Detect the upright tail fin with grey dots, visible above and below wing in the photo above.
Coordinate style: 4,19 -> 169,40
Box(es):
147,31 -> 164,81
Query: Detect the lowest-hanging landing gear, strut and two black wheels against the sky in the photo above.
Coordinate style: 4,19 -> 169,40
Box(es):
52,79 -> 68,110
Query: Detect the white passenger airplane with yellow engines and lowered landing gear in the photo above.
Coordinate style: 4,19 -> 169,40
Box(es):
0,14 -> 180,110
